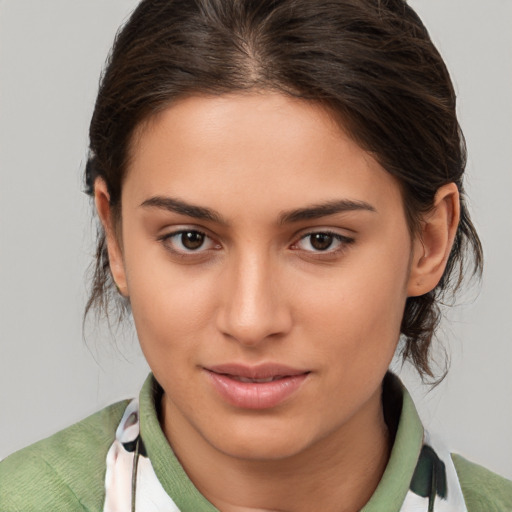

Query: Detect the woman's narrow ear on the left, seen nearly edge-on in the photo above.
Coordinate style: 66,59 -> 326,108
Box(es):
94,178 -> 128,297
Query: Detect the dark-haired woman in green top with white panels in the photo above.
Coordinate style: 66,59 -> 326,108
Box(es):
0,0 -> 512,511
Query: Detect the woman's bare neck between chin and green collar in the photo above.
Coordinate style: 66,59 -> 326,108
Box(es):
162,389 -> 390,512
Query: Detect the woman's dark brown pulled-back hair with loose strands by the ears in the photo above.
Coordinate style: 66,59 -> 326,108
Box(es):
86,0 -> 482,376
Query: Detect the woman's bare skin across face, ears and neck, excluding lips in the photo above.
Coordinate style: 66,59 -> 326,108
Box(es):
96,92 -> 458,512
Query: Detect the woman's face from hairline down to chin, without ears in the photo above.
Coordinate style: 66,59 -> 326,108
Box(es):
110,93 -> 413,459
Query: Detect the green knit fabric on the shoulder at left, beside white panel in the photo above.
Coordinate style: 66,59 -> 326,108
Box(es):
0,400 -> 128,512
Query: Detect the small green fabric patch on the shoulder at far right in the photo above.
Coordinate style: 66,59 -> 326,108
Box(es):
452,454 -> 512,512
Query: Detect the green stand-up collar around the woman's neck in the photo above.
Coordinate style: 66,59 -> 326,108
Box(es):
139,374 -> 423,512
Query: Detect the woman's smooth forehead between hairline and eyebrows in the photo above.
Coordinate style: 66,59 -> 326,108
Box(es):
123,92 -> 401,219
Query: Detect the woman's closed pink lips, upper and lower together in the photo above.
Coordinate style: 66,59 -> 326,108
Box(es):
204,363 -> 310,409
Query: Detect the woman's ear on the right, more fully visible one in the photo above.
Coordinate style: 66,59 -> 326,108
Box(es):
407,183 -> 460,297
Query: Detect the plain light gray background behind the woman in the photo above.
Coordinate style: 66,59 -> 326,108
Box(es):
0,0 -> 512,478
